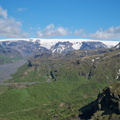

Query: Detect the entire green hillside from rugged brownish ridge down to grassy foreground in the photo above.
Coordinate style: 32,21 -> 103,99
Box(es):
0,50 -> 120,120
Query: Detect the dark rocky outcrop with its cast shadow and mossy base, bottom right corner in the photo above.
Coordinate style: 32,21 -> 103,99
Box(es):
79,82 -> 120,120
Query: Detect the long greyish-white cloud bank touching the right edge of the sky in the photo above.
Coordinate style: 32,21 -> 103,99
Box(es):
90,26 -> 120,39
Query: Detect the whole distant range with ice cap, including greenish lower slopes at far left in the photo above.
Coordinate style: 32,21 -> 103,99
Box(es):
0,38 -> 119,64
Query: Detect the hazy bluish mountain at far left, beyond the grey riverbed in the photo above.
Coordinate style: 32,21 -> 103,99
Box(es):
0,40 -> 50,64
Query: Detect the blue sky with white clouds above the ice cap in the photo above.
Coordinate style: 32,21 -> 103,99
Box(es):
0,0 -> 120,41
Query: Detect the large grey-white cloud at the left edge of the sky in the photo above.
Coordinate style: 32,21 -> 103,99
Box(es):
0,7 -> 28,37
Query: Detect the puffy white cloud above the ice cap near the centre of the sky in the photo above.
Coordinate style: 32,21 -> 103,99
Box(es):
36,24 -> 70,37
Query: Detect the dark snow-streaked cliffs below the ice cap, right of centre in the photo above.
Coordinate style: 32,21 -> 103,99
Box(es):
50,41 -> 107,53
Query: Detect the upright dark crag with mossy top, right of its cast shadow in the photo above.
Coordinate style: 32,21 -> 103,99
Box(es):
97,83 -> 120,114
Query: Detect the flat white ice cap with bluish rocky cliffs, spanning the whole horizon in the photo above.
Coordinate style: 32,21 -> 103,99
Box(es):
0,38 -> 119,56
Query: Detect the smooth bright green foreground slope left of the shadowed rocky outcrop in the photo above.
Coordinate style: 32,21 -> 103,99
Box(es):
0,80 -> 107,120
